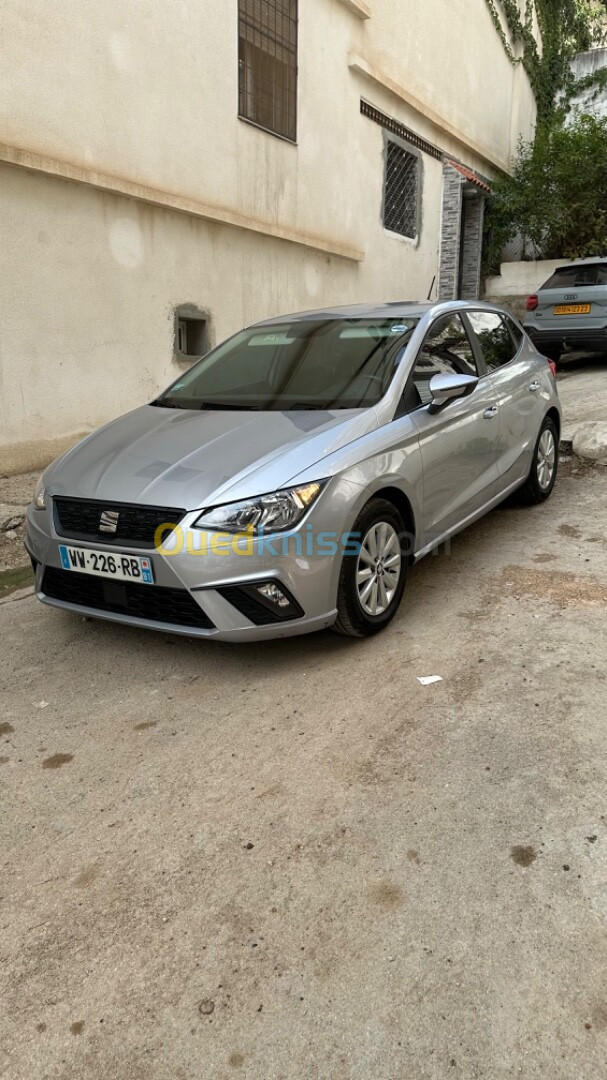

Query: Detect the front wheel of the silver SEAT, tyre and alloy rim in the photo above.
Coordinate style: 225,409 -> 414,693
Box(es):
332,499 -> 409,637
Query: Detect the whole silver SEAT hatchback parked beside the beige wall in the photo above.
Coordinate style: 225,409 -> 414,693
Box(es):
26,301 -> 561,642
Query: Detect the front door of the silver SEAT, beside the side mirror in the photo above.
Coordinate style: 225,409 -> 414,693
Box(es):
405,312 -> 498,548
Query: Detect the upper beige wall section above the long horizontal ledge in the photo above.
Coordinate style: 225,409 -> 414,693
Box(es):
0,0 -> 535,221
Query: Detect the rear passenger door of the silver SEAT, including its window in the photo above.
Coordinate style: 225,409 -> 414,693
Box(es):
464,310 -> 543,490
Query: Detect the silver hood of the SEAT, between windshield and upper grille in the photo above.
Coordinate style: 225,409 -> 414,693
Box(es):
44,405 -> 378,510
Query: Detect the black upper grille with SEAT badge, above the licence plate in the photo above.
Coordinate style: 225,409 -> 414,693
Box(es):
53,498 -> 181,548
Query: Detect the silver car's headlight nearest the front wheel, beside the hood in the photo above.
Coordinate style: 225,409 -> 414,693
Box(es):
194,484 -> 322,534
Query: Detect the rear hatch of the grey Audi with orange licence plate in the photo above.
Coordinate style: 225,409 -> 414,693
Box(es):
534,262 -> 607,333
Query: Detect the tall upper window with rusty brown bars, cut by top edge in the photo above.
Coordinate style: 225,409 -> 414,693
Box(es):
239,0 -> 297,143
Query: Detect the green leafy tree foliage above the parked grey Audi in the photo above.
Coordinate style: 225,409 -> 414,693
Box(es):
485,114 -> 607,273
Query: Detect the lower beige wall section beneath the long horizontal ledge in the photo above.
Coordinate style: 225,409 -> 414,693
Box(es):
0,151 -> 441,472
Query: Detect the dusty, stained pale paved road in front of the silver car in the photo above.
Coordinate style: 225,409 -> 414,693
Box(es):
0,457 -> 607,1080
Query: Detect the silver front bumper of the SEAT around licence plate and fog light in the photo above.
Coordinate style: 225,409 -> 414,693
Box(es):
26,490 -> 348,642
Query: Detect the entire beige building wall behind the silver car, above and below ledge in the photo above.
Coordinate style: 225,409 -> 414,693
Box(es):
0,0 -> 535,471
